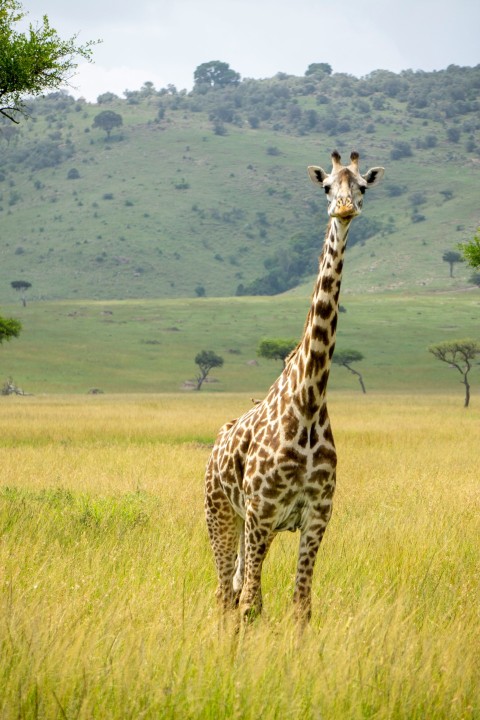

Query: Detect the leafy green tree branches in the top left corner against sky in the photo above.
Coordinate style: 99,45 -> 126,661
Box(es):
0,0 -> 96,123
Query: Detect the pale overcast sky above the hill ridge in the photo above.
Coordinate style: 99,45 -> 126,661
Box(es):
21,0 -> 480,101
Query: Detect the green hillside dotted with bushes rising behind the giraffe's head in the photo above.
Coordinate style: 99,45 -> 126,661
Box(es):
0,64 -> 480,303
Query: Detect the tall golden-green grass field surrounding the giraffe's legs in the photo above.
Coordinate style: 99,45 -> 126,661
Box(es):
0,393 -> 480,720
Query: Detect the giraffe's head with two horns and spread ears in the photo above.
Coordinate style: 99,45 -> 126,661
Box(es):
308,150 -> 385,221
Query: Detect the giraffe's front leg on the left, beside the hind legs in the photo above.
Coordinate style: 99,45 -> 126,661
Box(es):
239,508 -> 273,622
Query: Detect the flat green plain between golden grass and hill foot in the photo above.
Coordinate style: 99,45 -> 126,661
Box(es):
1,291 -> 480,402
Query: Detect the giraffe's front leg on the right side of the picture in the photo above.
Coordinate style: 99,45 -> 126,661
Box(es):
293,503 -> 332,624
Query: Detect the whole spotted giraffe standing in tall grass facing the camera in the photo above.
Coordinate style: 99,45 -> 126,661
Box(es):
205,151 -> 384,622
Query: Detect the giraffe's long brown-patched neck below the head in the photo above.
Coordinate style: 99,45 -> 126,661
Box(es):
285,218 -> 351,418
